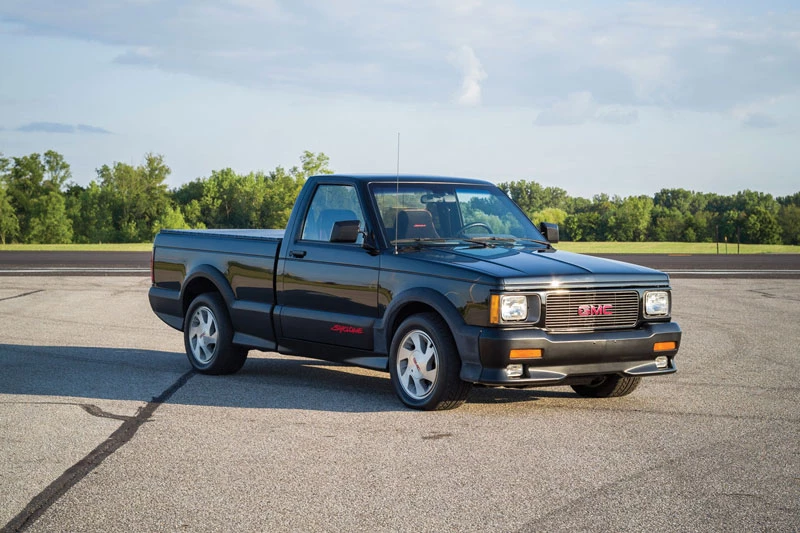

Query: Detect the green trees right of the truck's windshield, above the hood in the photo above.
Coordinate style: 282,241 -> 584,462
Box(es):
499,180 -> 800,244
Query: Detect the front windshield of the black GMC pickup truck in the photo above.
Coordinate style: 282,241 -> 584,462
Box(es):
371,182 -> 545,244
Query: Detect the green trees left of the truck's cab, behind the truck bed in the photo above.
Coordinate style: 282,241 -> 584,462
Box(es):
0,150 -> 332,244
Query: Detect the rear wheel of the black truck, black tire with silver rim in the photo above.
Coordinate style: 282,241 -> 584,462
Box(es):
183,293 -> 247,375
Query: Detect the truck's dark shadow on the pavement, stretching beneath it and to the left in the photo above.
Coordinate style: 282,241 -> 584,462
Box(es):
0,344 -> 577,412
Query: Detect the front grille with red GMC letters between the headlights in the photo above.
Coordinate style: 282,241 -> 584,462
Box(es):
545,291 -> 639,331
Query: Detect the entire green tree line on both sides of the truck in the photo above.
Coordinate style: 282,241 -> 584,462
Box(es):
0,150 -> 800,244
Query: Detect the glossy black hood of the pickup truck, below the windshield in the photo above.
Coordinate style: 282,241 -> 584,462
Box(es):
400,246 -> 669,288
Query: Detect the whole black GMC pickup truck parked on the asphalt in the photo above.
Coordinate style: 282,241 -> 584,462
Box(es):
149,175 -> 681,410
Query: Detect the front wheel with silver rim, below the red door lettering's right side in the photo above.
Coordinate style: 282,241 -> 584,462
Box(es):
389,313 -> 472,411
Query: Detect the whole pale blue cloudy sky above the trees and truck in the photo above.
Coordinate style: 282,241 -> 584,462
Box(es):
0,0 -> 800,198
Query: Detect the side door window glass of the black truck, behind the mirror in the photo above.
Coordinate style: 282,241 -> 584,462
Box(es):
300,185 -> 364,244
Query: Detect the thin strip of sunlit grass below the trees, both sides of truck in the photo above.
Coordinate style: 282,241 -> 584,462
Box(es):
0,242 -> 800,255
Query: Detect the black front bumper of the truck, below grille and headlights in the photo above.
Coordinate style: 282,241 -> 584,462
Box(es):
462,322 -> 681,386
